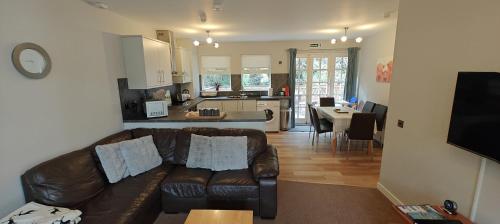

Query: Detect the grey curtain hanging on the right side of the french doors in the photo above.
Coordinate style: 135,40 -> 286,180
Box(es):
344,47 -> 359,101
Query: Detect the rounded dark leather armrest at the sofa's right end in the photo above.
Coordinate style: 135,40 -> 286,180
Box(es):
252,145 -> 280,181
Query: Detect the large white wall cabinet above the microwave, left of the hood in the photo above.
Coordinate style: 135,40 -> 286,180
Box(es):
122,36 -> 173,89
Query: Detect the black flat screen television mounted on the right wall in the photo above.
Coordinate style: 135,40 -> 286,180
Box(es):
448,72 -> 500,162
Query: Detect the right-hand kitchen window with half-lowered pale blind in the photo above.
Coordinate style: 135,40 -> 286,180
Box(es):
241,55 -> 271,91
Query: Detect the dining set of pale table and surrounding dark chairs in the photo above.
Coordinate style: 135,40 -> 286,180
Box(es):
307,97 -> 388,156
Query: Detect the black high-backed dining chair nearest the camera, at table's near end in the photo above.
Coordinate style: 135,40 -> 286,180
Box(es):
347,113 -> 375,153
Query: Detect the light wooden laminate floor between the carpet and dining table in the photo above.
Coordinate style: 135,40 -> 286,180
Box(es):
267,132 -> 382,188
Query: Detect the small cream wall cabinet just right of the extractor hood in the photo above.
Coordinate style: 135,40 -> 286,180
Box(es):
173,47 -> 193,83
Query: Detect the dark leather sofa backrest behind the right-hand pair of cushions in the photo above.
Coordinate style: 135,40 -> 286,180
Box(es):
174,128 -> 267,165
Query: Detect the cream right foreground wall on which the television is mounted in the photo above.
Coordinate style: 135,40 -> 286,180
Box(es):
380,0 -> 500,223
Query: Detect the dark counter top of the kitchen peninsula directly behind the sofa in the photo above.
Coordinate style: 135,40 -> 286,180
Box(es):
123,108 -> 266,123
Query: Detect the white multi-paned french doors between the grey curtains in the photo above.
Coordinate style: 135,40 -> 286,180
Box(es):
294,52 -> 347,124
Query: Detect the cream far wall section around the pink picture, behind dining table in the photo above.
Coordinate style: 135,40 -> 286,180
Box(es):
358,23 -> 396,105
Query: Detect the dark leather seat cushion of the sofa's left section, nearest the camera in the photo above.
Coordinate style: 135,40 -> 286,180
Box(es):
78,166 -> 169,223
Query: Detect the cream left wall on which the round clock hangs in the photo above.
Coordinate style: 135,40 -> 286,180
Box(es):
0,0 -> 154,217
